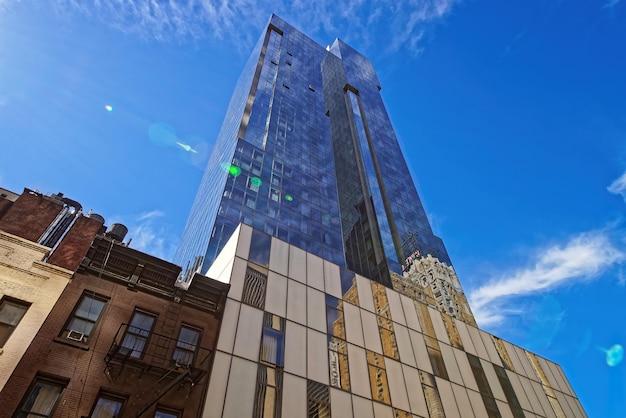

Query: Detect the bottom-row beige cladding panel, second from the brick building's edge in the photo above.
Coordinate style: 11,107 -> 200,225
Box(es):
222,357 -> 258,417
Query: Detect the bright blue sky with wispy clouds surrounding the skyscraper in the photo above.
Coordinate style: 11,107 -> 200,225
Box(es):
0,0 -> 626,417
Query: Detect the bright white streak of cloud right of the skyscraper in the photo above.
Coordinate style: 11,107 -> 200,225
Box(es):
469,231 -> 626,327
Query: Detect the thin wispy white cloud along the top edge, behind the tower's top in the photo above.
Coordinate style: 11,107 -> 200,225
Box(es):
7,0 -> 460,52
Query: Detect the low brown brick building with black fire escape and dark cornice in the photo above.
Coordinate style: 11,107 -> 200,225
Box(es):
0,190 -> 229,418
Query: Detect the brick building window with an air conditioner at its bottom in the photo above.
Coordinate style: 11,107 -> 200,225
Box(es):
61,291 -> 108,343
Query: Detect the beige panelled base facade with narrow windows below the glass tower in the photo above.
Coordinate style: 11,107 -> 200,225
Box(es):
204,225 -> 586,418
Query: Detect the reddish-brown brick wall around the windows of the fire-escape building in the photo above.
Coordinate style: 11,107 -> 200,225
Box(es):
0,273 -> 219,418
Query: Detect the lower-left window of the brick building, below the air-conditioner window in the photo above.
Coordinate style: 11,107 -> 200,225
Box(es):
15,376 -> 68,418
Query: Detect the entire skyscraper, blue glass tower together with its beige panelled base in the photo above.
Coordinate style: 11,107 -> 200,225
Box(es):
177,16 -> 585,418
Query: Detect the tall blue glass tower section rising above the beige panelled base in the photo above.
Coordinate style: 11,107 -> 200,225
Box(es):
175,16 -> 450,286
